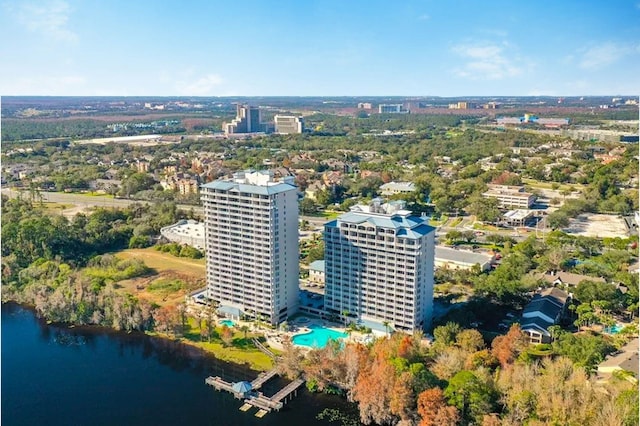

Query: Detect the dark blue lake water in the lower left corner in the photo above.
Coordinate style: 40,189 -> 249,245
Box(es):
1,304 -> 354,426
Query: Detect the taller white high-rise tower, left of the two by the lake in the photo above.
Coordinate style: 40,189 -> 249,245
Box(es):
200,171 -> 299,324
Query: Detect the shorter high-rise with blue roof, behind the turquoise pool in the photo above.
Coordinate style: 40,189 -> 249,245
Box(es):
324,199 -> 435,331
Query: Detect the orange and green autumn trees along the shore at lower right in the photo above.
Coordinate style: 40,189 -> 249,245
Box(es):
279,323 -> 638,426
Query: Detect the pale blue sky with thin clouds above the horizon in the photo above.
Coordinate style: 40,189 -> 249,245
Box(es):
0,0 -> 640,97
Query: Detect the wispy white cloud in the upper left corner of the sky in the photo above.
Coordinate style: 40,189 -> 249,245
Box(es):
7,0 -> 78,42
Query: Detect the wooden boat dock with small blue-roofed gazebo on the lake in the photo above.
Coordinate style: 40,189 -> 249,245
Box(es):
204,369 -> 304,417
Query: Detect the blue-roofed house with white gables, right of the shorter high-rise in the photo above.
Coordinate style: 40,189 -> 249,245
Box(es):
520,287 -> 571,343
